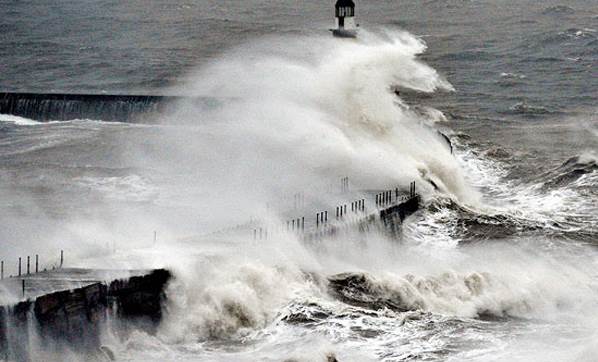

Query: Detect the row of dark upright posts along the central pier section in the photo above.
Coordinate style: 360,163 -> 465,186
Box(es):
253,177 -> 416,240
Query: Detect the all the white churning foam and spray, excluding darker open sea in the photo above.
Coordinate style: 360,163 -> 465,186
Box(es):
0,2 -> 598,362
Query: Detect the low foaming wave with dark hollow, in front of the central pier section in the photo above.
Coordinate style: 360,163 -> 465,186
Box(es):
328,272 -> 548,318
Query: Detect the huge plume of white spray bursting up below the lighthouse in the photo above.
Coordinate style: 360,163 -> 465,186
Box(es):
165,33 -> 475,212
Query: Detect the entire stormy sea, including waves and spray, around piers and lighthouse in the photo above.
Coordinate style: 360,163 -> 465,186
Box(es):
0,0 -> 598,362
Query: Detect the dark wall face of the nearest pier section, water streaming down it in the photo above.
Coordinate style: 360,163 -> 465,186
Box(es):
0,269 -> 171,361
